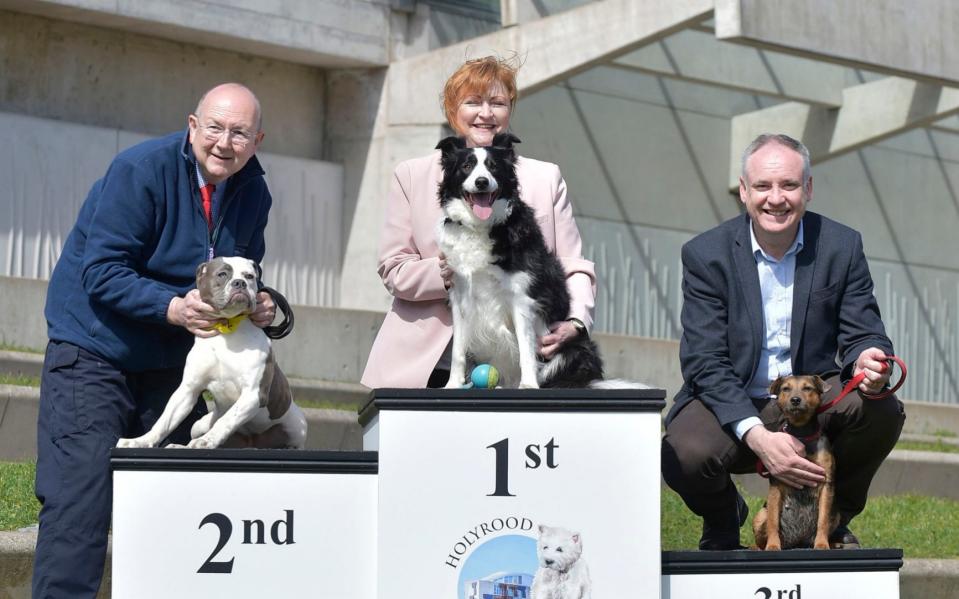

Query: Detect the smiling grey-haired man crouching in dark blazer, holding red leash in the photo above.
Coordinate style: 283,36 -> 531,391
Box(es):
662,134 -> 905,550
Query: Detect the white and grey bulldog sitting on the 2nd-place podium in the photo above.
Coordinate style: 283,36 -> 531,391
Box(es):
117,258 -> 307,448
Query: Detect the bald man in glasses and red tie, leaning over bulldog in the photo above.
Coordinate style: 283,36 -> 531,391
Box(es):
33,83 -> 275,599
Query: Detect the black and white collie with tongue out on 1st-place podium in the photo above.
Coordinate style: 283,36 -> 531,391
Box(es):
436,133 -> 603,388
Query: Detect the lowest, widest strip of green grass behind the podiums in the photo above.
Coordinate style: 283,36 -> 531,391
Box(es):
0,462 -> 959,559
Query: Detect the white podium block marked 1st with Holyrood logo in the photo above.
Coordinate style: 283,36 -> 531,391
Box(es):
360,389 -> 665,599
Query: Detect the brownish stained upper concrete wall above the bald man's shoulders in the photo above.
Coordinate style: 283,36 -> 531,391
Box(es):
0,11 -> 326,159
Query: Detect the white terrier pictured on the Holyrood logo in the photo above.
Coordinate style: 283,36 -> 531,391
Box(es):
530,524 -> 592,599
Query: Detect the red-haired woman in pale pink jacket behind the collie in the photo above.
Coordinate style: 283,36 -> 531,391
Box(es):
361,56 -> 596,388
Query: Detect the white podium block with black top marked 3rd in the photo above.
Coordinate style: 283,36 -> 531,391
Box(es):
662,549 -> 902,599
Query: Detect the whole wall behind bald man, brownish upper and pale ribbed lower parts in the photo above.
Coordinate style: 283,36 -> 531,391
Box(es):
0,11 -> 343,305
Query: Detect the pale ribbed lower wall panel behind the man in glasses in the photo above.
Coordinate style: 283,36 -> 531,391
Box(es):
0,112 -> 343,305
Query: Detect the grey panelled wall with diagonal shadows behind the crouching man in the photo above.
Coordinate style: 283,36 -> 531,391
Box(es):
512,39 -> 959,403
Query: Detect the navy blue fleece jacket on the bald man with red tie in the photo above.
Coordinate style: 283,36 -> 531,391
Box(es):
44,132 -> 272,372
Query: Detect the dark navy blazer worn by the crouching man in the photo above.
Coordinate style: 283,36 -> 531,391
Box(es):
667,212 -> 893,426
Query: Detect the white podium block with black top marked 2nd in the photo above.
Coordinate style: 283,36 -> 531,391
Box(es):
111,449 -> 377,599
